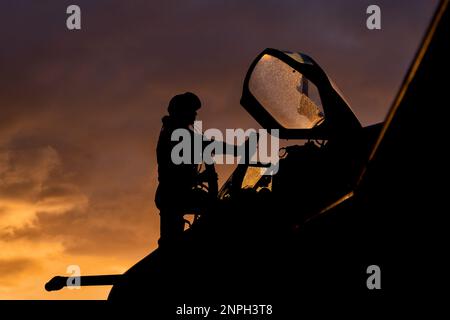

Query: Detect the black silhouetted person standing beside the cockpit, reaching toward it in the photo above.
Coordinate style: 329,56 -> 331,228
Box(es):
155,92 -> 217,245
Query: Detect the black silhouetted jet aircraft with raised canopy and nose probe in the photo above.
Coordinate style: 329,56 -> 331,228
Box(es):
46,1 -> 450,305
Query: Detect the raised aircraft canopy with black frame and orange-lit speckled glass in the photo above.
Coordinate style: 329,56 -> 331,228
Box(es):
241,49 -> 361,139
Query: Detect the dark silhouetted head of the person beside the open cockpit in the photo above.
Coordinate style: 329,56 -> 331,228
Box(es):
167,92 -> 202,125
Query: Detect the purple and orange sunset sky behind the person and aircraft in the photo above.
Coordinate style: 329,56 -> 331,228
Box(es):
0,0 -> 437,299
